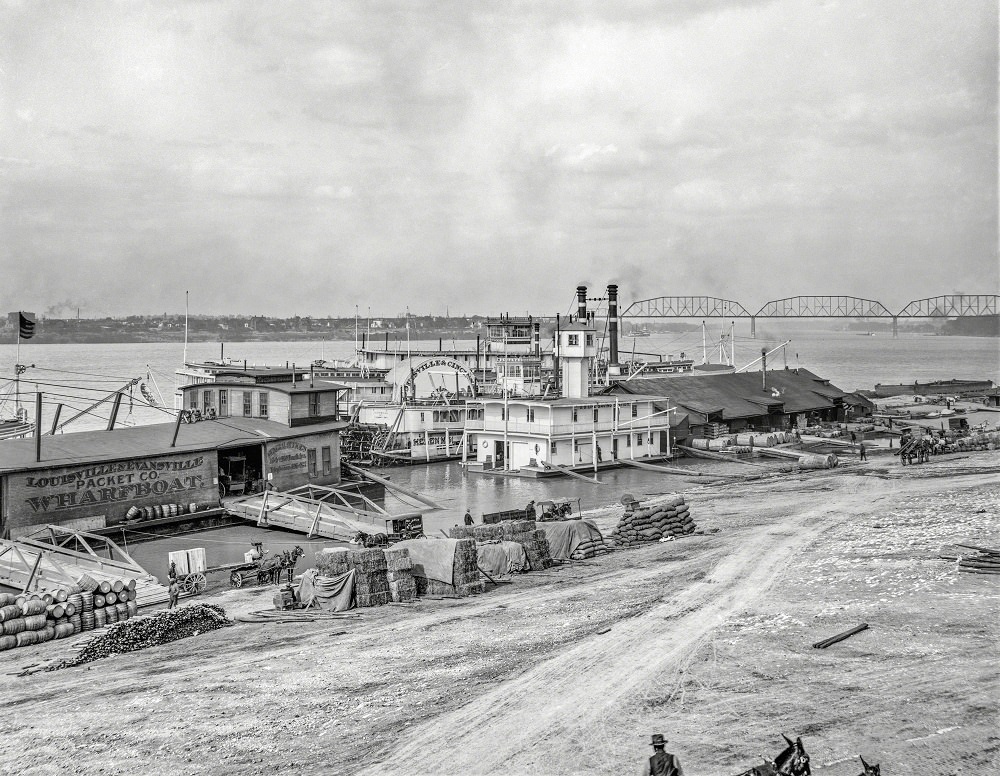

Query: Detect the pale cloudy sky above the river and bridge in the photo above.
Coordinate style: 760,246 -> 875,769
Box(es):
0,0 -> 1000,316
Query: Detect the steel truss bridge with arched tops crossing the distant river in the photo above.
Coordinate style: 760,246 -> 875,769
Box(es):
620,294 -> 1000,337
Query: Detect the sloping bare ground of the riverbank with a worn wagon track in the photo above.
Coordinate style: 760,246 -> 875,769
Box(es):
0,452 -> 1000,776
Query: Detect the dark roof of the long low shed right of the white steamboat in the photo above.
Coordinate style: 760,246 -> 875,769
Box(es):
608,369 -> 846,420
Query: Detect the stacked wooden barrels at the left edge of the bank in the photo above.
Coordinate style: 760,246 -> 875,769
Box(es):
0,575 -> 138,651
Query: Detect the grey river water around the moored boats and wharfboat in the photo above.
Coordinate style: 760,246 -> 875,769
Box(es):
0,330 -> 1000,574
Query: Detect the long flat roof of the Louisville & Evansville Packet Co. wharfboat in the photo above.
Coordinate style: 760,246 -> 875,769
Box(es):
0,418 -> 348,472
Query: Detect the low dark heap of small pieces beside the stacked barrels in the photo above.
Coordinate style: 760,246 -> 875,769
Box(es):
48,604 -> 232,671
